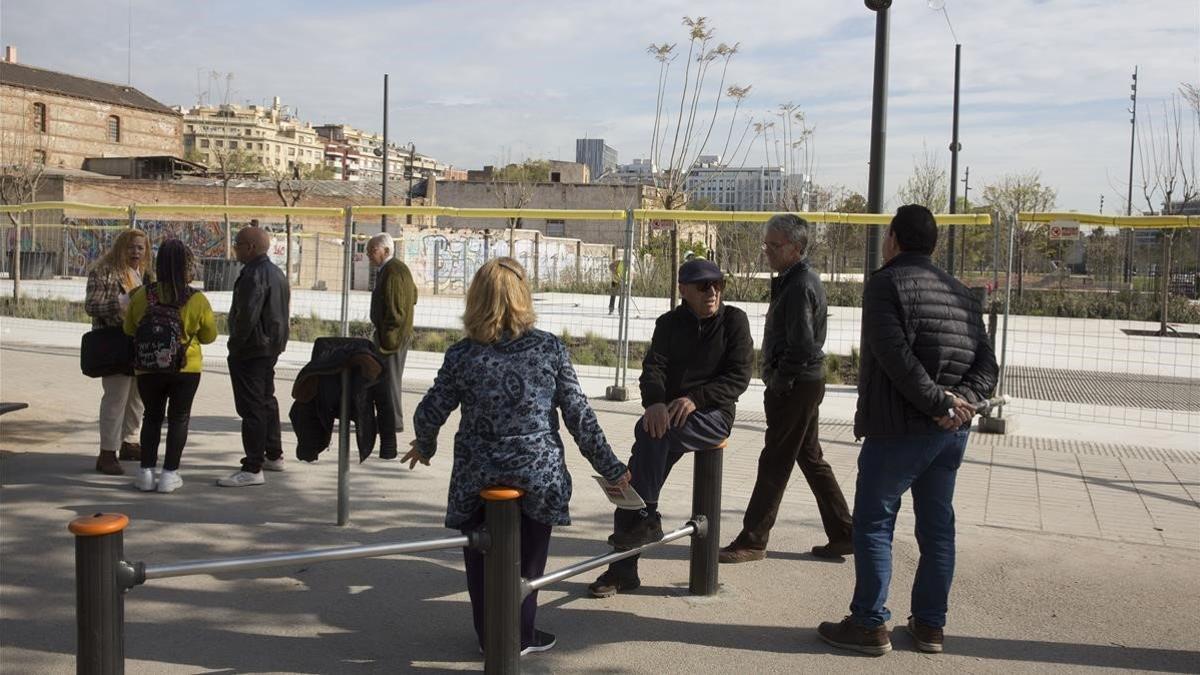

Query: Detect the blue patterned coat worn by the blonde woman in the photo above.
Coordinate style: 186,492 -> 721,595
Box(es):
413,330 -> 625,527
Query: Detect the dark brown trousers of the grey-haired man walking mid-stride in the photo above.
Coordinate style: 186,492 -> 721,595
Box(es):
734,380 -> 852,549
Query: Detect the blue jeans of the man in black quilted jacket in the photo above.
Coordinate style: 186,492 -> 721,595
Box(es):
850,429 -> 967,628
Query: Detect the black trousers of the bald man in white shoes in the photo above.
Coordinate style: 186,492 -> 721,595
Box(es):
228,356 -> 283,473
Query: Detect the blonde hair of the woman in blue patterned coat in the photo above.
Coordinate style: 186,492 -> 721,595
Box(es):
462,258 -> 536,345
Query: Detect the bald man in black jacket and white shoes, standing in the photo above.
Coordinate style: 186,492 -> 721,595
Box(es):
217,223 -> 290,488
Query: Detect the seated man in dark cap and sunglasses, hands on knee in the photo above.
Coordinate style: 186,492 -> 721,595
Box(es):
588,259 -> 754,598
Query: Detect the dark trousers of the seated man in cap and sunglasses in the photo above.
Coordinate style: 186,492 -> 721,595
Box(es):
608,410 -> 730,577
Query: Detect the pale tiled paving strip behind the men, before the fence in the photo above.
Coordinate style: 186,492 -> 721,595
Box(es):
583,401 -> 1200,550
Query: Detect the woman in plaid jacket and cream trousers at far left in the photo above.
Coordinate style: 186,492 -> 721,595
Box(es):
83,229 -> 152,476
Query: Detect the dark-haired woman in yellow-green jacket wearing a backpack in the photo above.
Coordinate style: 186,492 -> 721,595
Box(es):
125,239 -> 217,492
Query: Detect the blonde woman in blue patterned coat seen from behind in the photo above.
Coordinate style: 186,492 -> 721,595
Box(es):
401,258 -> 629,653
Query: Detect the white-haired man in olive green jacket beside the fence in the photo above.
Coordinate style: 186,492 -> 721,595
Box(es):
367,232 -> 416,459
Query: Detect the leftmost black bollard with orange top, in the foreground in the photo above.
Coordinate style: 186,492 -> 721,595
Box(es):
67,513 -> 130,675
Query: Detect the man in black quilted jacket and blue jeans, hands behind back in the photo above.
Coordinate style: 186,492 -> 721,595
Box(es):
817,204 -> 997,655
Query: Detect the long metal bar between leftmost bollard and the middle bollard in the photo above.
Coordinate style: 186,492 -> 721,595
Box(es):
145,536 -> 470,580
